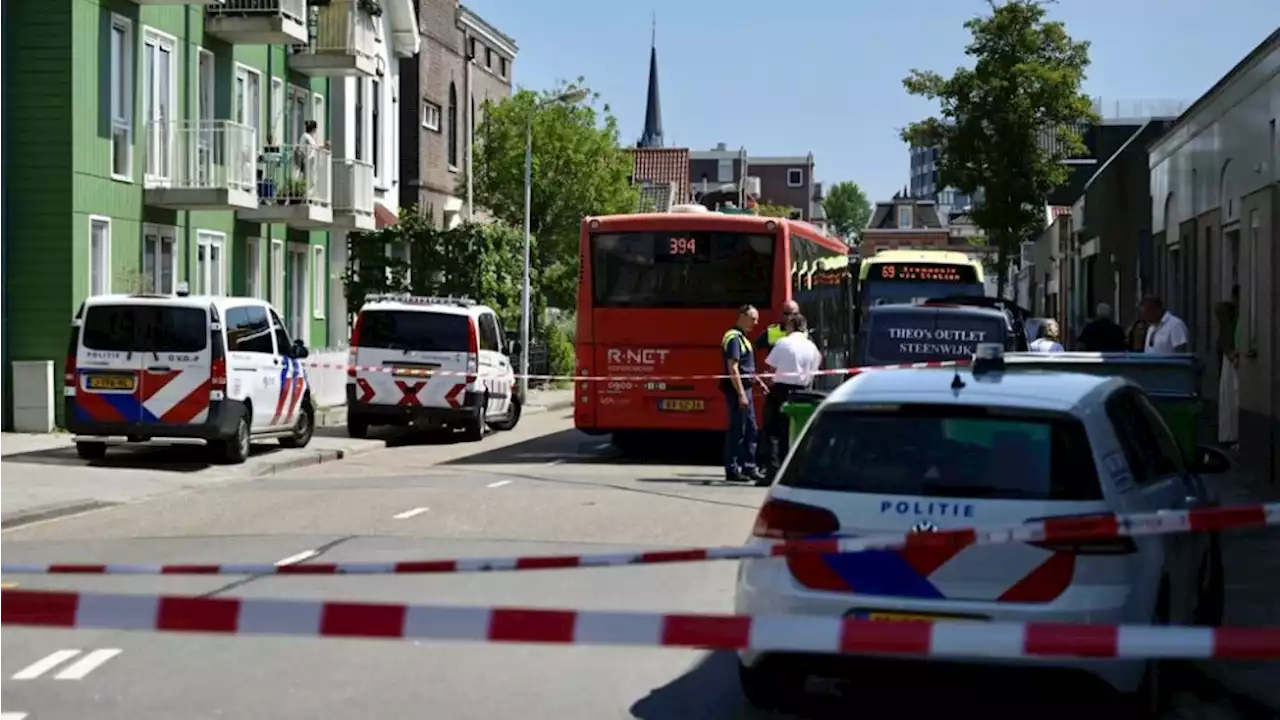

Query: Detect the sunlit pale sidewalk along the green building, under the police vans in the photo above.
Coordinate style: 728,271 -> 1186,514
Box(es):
0,389 -> 573,530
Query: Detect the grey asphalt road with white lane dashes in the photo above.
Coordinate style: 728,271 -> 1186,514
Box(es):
0,413 -> 1259,720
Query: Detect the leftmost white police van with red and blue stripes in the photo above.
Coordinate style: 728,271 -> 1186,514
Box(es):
63,283 -> 315,464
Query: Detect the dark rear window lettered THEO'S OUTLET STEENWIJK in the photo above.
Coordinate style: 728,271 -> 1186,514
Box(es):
867,309 -> 1009,363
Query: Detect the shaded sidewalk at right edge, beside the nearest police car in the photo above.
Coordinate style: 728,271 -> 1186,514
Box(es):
1199,456 -> 1280,716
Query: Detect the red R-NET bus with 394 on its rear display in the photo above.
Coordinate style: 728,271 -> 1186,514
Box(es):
573,205 -> 851,448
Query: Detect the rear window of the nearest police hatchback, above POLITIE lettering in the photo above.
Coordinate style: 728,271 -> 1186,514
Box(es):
780,405 -> 1102,501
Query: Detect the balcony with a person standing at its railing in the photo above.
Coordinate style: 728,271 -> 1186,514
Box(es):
238,145 -> 333,229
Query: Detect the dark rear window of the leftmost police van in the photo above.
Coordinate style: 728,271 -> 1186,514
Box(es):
81,305 -> 209,352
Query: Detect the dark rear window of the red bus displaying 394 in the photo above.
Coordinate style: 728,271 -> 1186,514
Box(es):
590,231 -> 776,307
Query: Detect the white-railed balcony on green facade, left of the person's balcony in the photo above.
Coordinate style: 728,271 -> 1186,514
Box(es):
143,120 -> 259,210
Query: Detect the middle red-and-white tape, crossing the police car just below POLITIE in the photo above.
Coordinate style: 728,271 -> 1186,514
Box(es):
0,502 -> 1280,575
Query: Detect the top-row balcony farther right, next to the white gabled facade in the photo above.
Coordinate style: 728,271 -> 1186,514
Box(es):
289,0 -> 381,77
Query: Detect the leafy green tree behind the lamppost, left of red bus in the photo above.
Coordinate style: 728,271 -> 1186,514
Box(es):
461,78 -> 639,307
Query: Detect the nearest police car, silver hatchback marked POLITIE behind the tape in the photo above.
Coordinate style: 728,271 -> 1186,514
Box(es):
735,346 -> 1229,710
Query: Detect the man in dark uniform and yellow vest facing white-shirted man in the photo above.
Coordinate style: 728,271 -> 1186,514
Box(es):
721,305 -> 762,482
